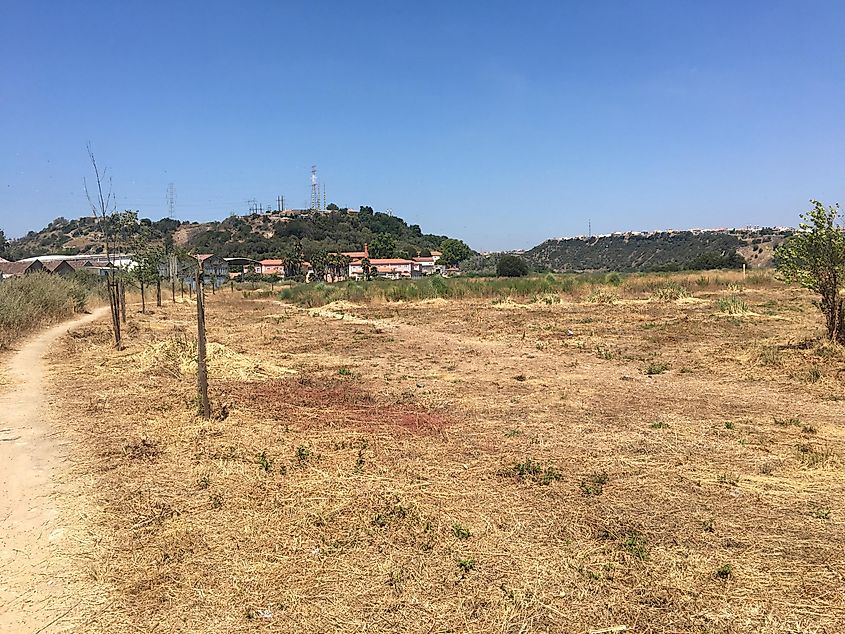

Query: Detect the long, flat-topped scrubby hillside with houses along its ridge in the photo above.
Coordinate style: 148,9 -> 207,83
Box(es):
523,229 -> 787,272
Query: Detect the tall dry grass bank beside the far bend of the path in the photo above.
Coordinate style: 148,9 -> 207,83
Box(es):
0,273 -> 103,350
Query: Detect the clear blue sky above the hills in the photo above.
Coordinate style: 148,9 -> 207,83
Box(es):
0,0 -> 845,249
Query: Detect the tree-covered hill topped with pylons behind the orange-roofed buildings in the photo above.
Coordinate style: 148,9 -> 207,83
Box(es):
1,207 -> 454,260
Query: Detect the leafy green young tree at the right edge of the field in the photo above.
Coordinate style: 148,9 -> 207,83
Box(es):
775,200 -> 845,344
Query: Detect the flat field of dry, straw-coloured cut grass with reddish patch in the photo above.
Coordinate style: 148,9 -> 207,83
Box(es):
51,273 -> 845,634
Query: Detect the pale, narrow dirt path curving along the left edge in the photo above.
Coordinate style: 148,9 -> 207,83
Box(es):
0,308 -> 107,633
